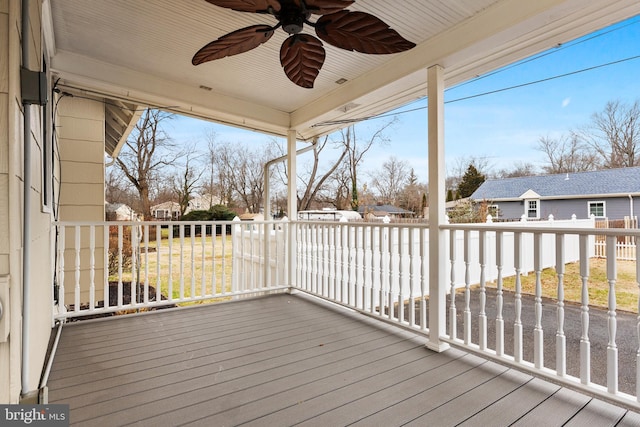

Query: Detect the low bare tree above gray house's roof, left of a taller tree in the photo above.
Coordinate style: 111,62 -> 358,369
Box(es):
538,132 -> 598,174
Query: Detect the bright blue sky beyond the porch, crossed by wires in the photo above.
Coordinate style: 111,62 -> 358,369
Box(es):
167,12 -> 640,182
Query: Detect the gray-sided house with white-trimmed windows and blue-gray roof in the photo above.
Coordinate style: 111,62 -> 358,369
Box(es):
471,167 -> 640,220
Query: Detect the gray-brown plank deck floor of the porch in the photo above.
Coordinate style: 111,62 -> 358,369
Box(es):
48,295 -> 640,426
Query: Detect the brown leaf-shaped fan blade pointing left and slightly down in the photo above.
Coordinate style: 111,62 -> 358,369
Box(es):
191,25 -> 273,65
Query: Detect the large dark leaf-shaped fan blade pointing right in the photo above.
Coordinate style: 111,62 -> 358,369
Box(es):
316,10 -> 415,54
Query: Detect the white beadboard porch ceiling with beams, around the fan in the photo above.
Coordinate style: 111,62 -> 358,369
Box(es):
43,0 -> 640,140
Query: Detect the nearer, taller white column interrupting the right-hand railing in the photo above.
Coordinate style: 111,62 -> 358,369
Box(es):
427,65 -> 449,351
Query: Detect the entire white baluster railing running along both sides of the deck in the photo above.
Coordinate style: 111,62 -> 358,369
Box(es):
51,221 -> 640,408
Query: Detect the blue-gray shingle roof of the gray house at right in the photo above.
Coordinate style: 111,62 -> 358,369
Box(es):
471,167 -> 640,201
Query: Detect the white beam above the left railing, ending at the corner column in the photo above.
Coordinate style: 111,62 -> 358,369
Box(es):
51,50 -> 290,135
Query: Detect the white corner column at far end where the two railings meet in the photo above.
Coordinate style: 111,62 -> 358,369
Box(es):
287,129 -> 298,290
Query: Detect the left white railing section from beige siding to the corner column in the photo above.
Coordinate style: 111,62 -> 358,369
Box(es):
54,220 -> 288,319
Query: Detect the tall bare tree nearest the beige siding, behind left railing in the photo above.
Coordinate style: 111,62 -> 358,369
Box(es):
116,109 -> 180,219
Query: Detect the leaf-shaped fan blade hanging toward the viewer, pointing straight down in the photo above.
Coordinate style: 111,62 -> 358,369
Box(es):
280,34 -> 325,89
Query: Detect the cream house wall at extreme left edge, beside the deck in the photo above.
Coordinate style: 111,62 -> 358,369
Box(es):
0,0 -> 52,403
